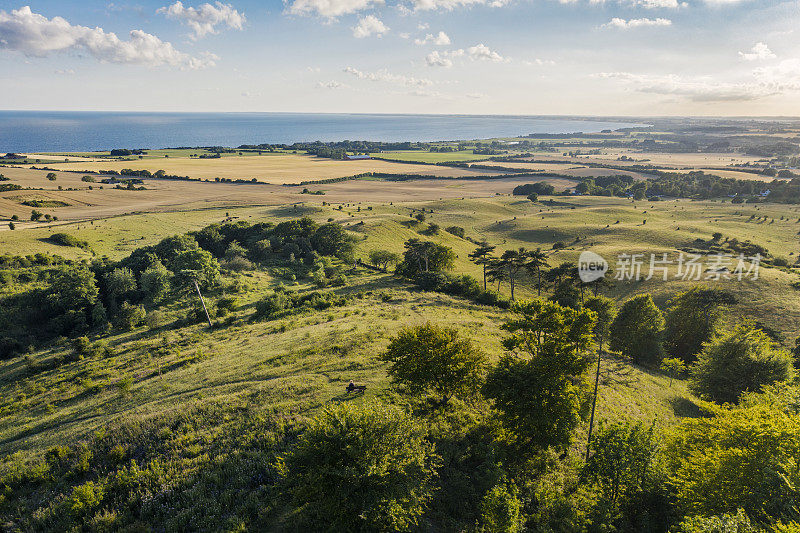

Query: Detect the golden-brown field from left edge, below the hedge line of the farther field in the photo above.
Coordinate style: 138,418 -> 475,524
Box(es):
0,165 -> 575,225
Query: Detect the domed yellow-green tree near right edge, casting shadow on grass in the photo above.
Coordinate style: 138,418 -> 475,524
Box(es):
689,323 -> 795,403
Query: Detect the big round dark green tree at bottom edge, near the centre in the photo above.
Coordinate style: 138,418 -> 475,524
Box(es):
281,403 -> 438,531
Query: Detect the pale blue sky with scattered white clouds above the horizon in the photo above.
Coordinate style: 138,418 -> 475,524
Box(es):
0,0 -> 800,115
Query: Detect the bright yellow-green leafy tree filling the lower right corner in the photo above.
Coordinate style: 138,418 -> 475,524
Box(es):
663,387 -> 800,522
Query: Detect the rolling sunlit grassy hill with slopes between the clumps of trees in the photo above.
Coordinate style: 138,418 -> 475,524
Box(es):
0,190 -> 800,531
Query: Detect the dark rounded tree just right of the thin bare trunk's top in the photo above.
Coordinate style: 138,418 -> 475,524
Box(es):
611,294 -> 664,366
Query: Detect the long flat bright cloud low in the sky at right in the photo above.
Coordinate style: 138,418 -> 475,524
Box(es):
597,70 -> 772,102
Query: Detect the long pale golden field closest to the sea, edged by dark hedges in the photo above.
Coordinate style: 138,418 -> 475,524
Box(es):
42,154 -> 506,185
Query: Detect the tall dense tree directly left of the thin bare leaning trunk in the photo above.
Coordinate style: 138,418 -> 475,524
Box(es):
483,300 -> 595,449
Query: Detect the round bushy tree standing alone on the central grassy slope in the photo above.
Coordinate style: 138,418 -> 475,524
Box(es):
383,324 -> 486,404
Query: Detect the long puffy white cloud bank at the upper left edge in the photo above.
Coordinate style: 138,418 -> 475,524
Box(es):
0,6 -> 219,69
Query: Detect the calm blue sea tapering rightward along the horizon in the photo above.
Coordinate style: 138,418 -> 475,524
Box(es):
0,111 -> 635,153
